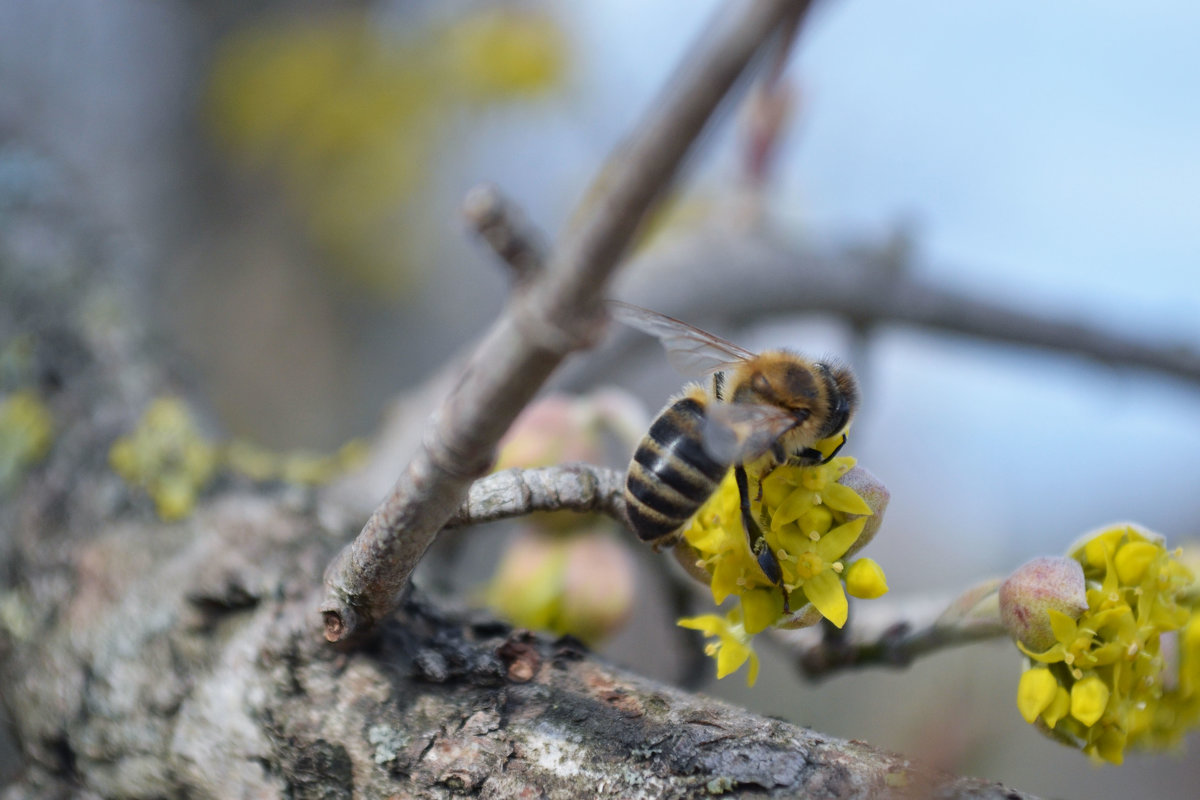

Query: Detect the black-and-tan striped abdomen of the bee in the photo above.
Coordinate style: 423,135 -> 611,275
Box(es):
625,397 -> 730,541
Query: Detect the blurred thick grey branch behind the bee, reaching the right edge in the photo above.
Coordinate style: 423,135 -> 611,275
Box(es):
583,225 -> 1200,385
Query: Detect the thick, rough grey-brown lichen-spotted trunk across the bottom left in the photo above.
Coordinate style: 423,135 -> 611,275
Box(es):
0,152 -> 1041,800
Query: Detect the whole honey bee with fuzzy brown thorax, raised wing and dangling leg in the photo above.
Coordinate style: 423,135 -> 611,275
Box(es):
610,301 -> 858,612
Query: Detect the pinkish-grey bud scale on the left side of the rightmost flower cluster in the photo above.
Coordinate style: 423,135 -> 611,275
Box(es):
1000,555 -> 1087,651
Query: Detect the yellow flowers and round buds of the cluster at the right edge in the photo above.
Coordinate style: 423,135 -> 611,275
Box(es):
1016,524 -> 1200,764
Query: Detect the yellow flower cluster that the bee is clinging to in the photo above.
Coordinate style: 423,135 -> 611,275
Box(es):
678,438 -> 888,685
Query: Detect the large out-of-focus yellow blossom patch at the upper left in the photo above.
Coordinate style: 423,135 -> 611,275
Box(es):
204,8 -> 569,297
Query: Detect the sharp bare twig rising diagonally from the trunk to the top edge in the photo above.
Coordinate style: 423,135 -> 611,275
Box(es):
320,0 -> 809,642
